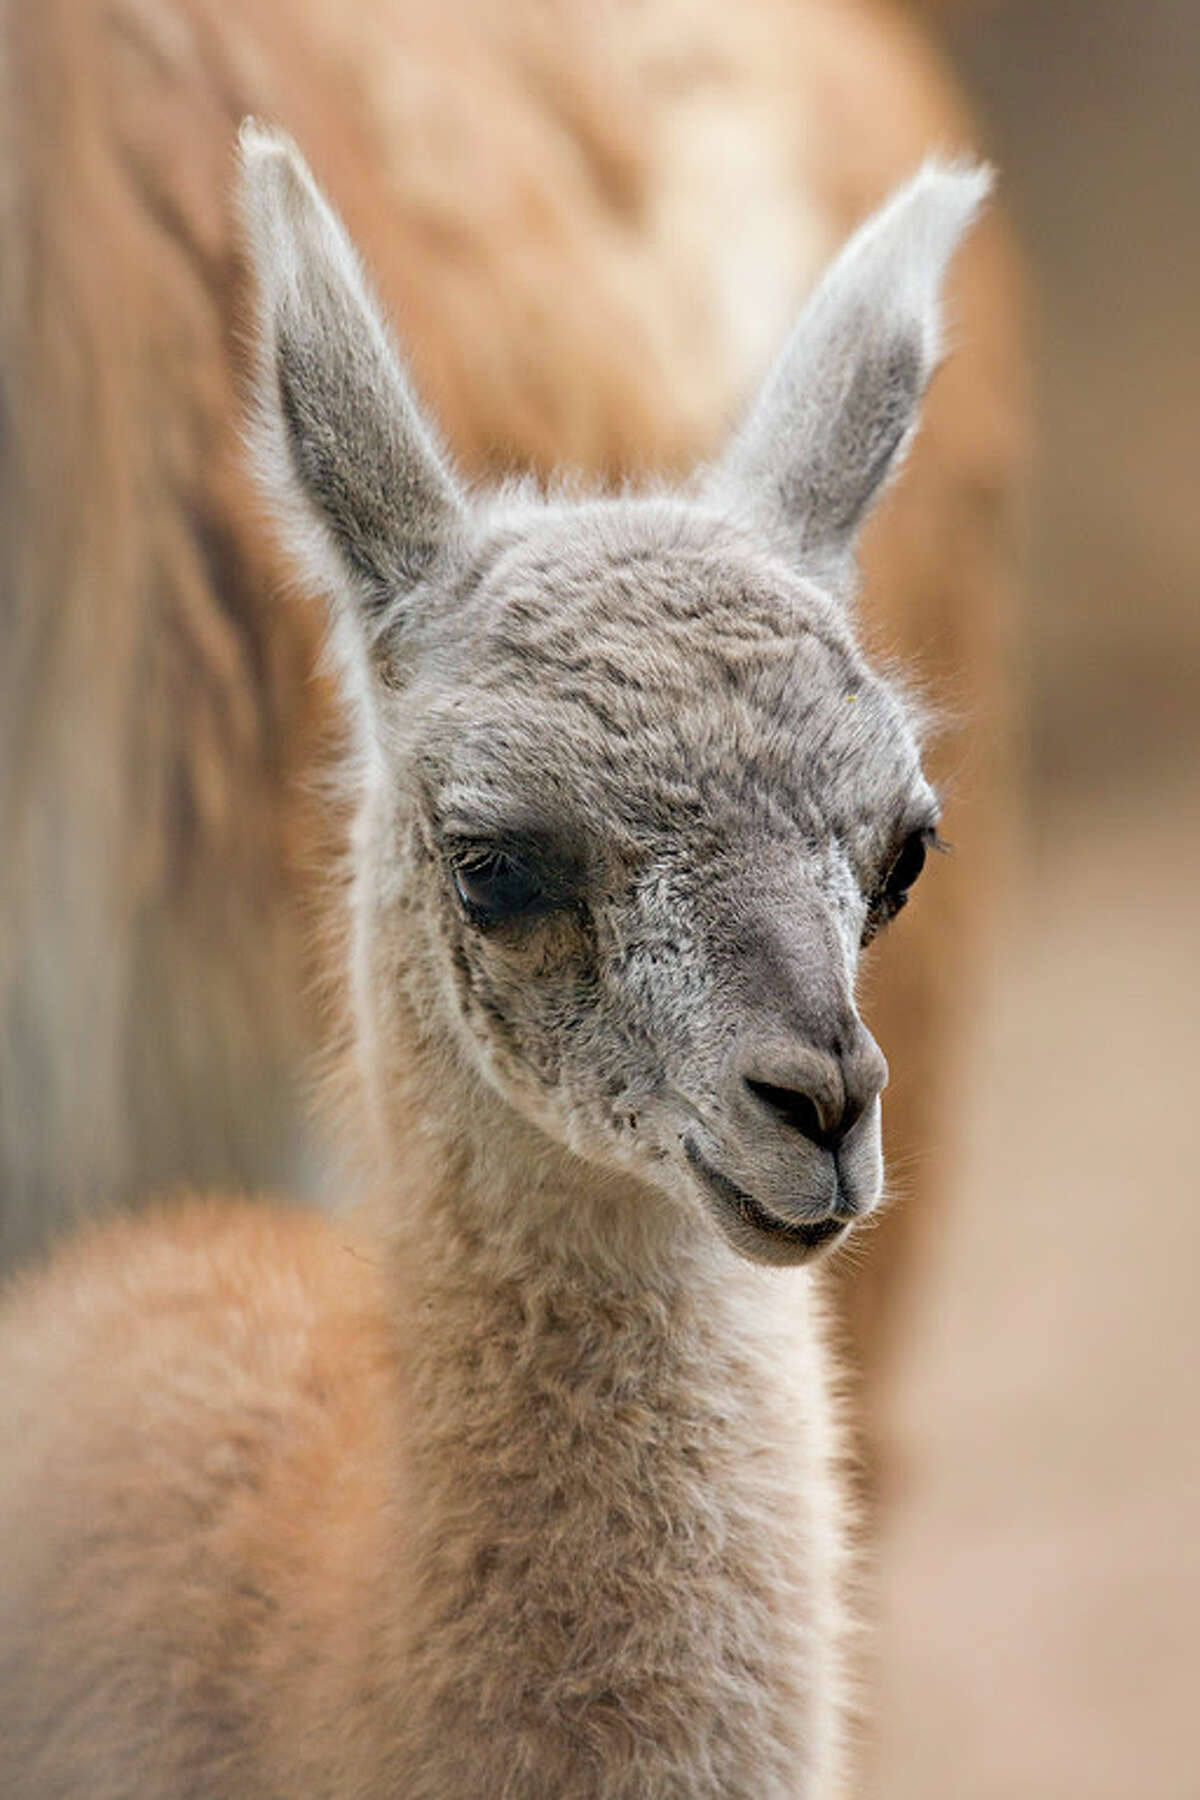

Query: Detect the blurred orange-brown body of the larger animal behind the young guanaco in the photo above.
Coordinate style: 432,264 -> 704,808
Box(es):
0,0 -> 1025,1389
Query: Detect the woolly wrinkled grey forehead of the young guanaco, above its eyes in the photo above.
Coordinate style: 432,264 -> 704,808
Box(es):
408,495 -> 936,900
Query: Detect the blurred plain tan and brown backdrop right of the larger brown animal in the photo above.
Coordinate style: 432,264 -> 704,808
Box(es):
880,0 -> 1200,1800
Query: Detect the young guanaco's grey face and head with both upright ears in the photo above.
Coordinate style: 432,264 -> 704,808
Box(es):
239,124 -> 988,1262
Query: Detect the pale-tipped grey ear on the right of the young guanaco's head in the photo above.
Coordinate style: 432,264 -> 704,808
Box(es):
709,162 -> 991,594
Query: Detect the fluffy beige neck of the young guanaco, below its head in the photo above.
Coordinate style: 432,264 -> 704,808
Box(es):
356,1008 -> 838,1800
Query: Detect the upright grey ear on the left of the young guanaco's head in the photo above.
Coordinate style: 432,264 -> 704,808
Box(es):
237,119 -> 464,666
